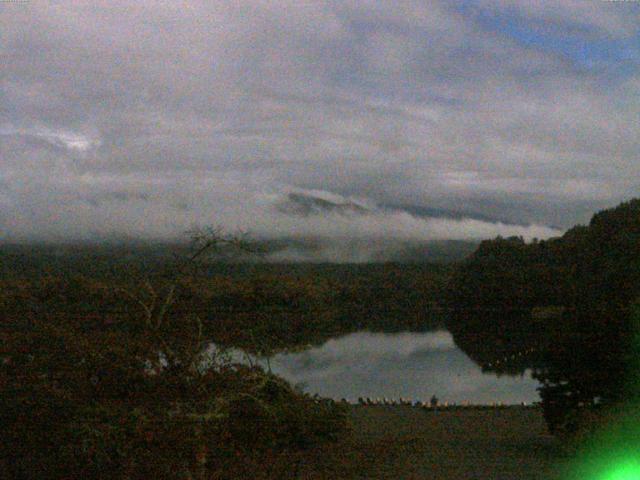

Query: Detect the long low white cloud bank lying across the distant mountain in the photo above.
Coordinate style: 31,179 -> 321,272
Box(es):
0,181 -> 562,262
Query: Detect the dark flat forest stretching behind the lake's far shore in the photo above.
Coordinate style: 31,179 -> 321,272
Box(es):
0,258 -> 450,353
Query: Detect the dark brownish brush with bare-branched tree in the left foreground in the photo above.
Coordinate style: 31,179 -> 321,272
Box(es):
0,232 -> 346,480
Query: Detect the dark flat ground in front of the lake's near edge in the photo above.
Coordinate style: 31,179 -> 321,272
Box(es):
299,405 -> 565,480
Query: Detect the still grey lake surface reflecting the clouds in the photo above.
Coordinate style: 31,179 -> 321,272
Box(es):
269,331 -> 540,404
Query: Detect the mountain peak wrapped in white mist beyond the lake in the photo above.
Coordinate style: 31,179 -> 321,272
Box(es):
255,189 -> 560,262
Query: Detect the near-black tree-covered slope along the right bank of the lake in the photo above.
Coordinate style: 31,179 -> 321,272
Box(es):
447,200 -> 640,430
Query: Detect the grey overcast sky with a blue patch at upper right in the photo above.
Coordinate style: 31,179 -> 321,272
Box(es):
0,0 -> 640,244
